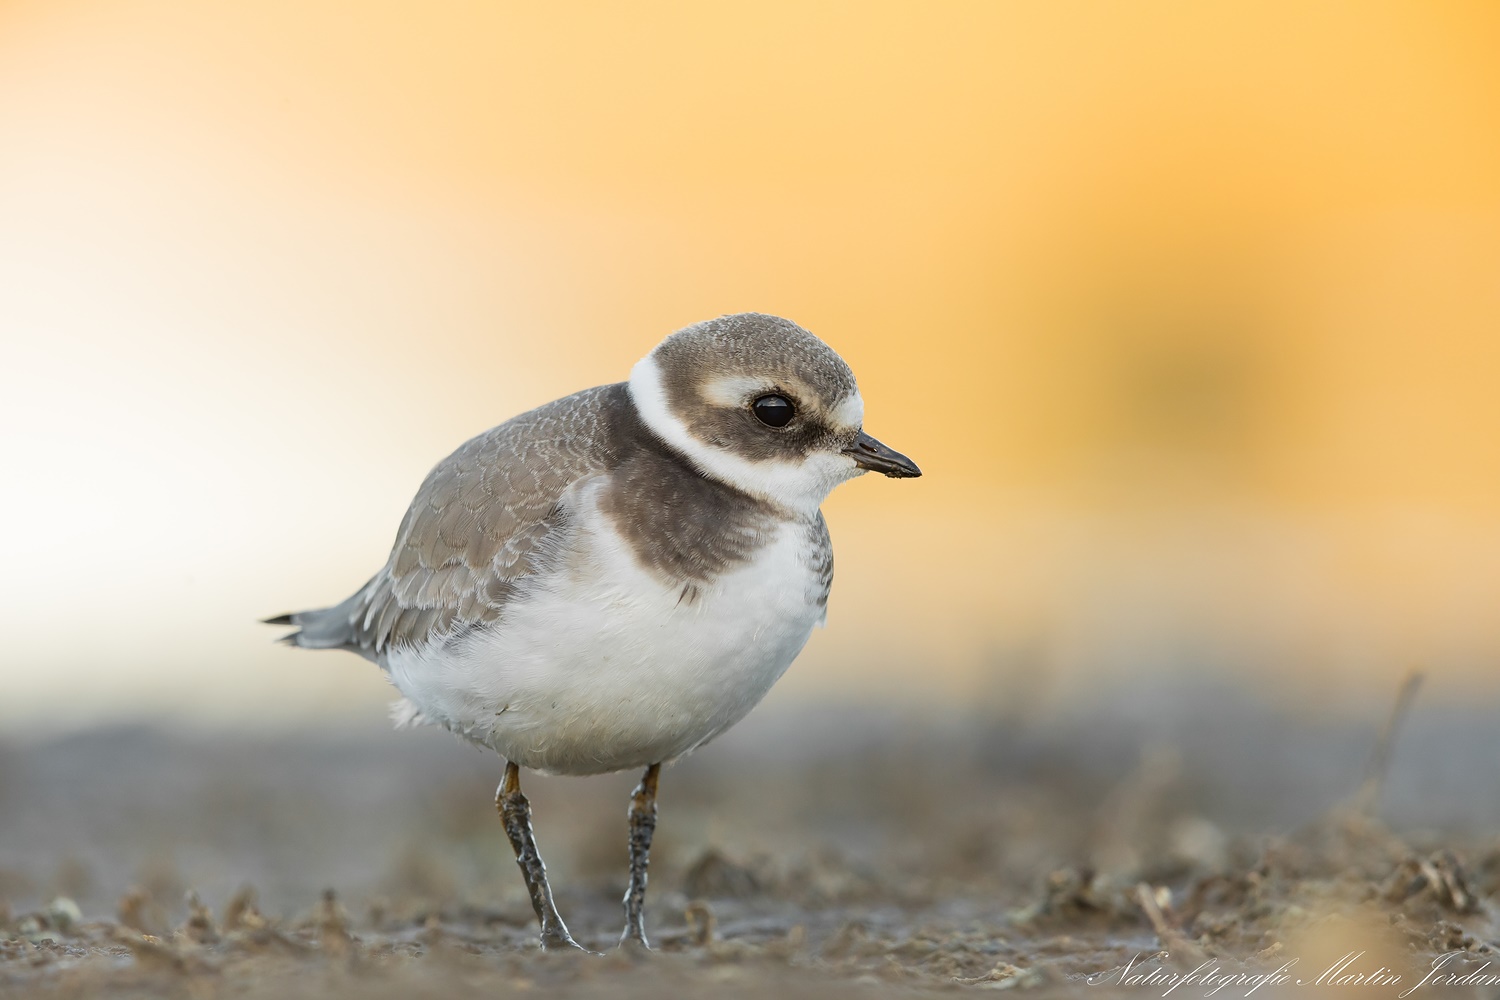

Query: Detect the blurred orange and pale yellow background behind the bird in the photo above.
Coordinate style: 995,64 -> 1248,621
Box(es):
0,0 -> 1500,730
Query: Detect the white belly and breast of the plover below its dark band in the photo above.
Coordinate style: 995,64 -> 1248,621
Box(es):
389,482 -> 824,774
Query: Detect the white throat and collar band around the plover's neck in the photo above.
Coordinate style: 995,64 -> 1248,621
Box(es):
627,355 -> 864,517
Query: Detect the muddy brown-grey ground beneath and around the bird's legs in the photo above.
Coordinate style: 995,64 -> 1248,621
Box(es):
0,682 -> 1500,999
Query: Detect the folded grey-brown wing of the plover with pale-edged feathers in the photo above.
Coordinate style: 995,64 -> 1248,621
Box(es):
291,385 -> 629,663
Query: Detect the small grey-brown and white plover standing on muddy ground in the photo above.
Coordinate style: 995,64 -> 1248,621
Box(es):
264,313 -> 921,951
